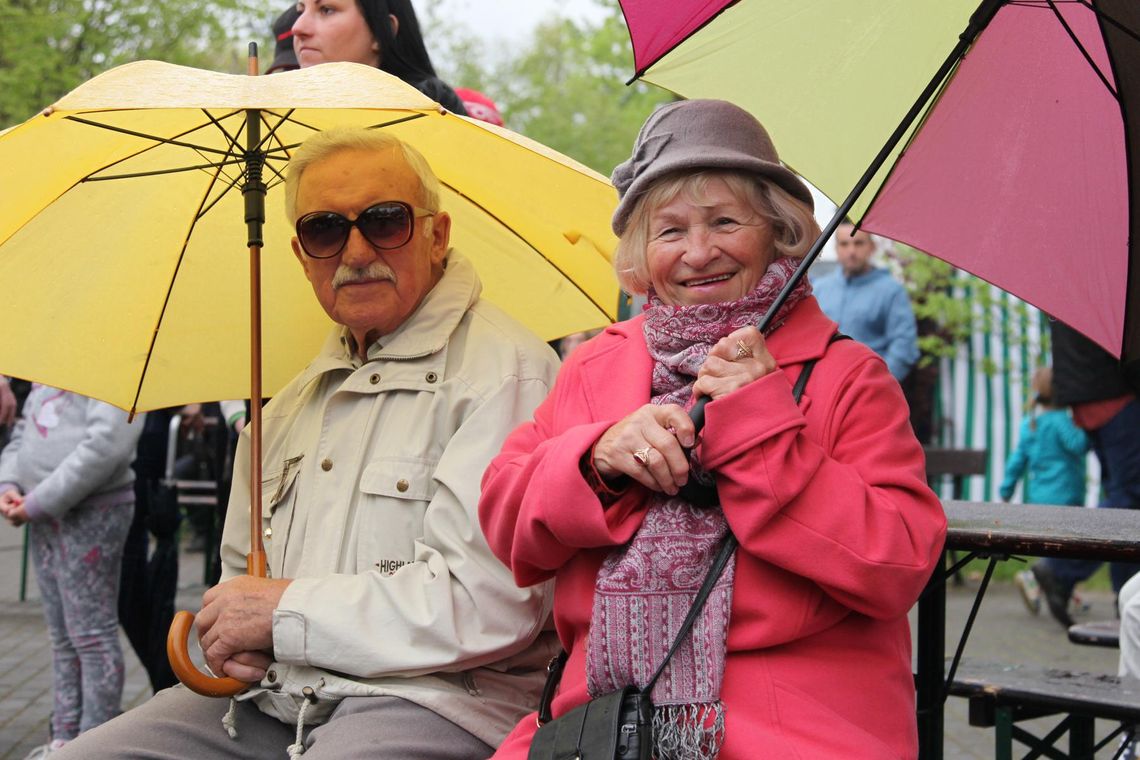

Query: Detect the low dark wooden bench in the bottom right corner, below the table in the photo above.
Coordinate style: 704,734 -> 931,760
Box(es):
950,660 -> 1140,760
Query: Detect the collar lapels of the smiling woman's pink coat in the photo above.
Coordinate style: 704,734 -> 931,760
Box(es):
580,295 -> 838,419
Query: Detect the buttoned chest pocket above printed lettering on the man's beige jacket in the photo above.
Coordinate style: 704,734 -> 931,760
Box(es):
356,457 -> 437,575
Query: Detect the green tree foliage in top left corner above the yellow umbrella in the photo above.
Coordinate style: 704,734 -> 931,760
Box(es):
0,0 -> 275,128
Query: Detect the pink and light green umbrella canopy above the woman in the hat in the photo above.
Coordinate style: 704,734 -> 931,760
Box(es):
621,0 -> 1140,359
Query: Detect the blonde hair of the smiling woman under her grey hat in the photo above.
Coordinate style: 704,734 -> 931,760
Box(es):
613,170 -> 820,294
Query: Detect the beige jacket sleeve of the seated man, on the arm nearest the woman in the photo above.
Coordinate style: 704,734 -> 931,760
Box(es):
274,371 -> 553,678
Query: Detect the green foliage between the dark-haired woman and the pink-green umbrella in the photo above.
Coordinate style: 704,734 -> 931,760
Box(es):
424,0 -> 673,174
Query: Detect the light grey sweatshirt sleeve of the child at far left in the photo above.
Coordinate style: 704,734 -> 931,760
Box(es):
25,399 -> 143,520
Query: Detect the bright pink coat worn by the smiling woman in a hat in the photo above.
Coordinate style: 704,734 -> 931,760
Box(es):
479,299 -> 946,760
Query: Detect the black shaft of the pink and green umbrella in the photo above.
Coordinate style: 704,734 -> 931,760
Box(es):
689,0 -> 1007,431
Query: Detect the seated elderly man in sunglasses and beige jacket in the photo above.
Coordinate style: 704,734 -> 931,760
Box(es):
59,130 -> 556,760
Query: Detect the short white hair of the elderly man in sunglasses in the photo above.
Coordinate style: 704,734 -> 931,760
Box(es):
285,126 -> 440,223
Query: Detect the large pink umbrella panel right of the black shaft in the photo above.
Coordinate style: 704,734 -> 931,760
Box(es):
863,3 -> 1140,357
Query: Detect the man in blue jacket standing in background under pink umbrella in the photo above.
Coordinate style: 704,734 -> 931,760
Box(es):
813,222 -> 919,382
